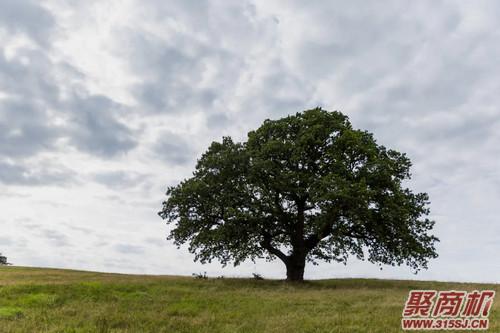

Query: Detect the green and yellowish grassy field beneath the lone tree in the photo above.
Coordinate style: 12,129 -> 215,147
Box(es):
0,267 -> 500,333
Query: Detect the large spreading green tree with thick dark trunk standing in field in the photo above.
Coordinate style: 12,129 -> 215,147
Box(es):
159,108 -> 438,281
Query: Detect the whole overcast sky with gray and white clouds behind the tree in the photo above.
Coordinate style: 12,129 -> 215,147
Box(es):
0,0 -> 500,282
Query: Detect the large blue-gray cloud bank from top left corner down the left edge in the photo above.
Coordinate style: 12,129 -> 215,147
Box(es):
0,1 -> 136,166
